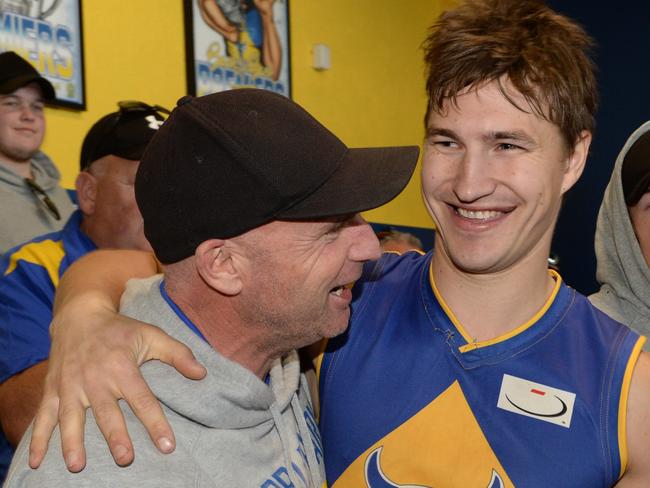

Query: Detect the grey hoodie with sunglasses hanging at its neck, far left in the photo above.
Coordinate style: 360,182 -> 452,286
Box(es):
0,152 -> 75,254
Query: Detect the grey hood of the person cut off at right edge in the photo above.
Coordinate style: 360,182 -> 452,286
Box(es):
589,121 -> 650,349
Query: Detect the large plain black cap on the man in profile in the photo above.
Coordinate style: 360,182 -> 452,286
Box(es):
135,88 -> 419,264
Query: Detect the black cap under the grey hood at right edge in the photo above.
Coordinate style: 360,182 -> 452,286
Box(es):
621,131 -> 650,207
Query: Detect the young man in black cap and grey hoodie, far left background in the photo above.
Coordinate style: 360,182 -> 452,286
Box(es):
0,51 -> 75,254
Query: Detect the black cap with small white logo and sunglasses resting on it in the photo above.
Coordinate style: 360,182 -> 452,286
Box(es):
79,100 -> 169,171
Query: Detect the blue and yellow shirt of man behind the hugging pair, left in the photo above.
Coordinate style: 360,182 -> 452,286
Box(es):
0,211 -> 95,383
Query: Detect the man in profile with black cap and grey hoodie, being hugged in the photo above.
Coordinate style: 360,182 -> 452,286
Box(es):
5,89 -> 419,488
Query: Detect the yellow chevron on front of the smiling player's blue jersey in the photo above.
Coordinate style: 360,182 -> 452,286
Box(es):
332,381 -> 514,488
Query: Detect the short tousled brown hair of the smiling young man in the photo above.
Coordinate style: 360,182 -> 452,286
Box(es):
423,0 -> 598,148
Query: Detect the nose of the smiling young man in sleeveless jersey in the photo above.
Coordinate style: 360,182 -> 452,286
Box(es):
453,148 -> 495,203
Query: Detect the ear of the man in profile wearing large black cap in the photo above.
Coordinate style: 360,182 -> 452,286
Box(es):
194,239 -> 243,296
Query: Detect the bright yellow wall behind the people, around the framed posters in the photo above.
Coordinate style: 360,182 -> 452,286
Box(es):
44,0 -> 453,227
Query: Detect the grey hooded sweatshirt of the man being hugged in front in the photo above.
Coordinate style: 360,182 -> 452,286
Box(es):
6,276 -> 324,488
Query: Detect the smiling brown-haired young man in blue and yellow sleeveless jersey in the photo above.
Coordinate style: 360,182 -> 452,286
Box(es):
21,0 -> 650,487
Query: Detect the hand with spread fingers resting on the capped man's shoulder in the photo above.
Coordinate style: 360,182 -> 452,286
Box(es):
29,314 -> 200,472
